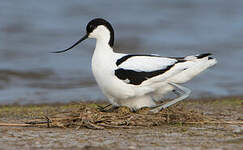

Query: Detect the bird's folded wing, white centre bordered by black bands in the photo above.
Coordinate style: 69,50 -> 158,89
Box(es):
115,55 -> 184,85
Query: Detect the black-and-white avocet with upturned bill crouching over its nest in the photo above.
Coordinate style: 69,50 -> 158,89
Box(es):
53,18 -> 217,113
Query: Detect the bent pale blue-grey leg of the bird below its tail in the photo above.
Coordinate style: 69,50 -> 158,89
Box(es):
150,83 -> 191,113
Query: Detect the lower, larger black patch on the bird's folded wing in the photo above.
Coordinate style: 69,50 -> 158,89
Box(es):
115,64 -> 175,85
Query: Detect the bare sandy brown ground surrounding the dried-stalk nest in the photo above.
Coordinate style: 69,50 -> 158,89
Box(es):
0,98 -> 243,150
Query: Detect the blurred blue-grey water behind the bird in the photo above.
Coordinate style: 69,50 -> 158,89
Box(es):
0,0 -> 243,104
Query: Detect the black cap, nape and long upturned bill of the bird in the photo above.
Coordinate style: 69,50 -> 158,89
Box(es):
53,18 -> 114,53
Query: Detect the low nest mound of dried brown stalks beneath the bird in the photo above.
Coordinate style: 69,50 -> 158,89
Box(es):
21,103 -> 213,129
